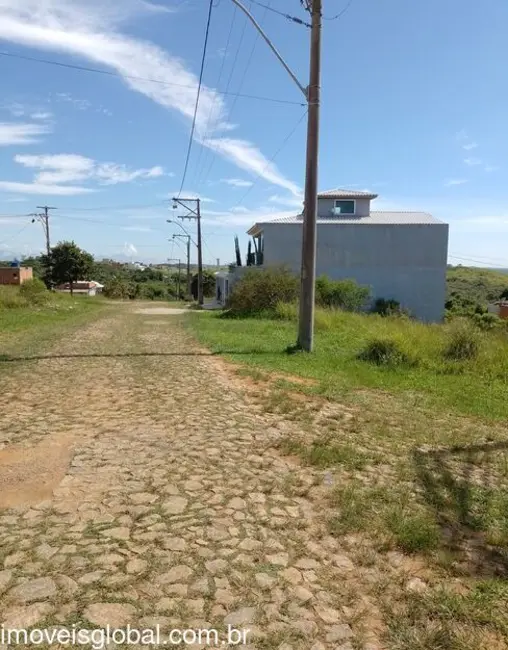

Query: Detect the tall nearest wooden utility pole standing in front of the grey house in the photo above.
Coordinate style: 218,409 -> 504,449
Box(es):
297,0 -> 322,352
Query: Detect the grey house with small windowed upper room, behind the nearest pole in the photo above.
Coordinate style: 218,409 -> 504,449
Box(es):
217,189 -> 448,322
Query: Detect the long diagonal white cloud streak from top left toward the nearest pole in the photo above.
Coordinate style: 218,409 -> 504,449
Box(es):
0,0 -> 298,193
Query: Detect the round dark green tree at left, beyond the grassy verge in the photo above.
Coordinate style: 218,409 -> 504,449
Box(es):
42,241 -> 94,296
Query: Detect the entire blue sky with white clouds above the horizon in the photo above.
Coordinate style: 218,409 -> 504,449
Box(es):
0,0 -> 508,266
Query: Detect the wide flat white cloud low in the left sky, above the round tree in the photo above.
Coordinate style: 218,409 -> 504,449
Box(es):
7,154 -> 164,194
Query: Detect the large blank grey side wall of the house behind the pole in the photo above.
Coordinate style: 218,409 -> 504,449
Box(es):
263,223 -> 448,322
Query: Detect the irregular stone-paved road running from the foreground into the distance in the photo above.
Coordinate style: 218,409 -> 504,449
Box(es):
0,306 -> 368,650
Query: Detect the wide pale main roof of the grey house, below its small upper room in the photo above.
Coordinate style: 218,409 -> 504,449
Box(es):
247,211 -> 443,235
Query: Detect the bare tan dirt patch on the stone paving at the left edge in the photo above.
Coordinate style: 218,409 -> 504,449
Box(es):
0,434 -> 72,508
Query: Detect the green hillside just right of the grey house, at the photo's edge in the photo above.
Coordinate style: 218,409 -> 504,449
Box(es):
447,266 -> 508,306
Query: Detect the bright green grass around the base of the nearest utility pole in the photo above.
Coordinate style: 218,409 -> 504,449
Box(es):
187,310 -> 508,419
